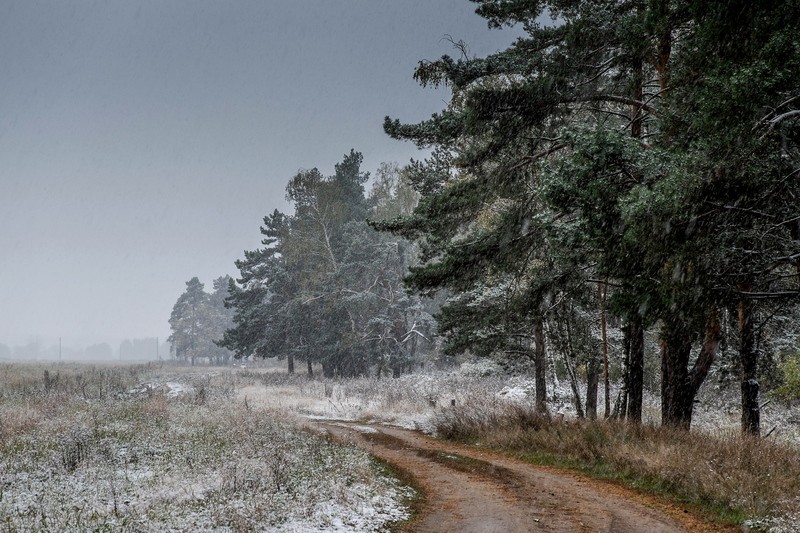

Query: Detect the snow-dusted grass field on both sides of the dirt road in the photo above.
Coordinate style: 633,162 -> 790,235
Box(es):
0,364 -> 800,532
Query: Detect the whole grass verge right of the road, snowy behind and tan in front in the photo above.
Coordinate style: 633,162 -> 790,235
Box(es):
231,362 -> 800,533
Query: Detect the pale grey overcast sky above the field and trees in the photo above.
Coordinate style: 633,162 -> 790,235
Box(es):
0,0 -> 515,345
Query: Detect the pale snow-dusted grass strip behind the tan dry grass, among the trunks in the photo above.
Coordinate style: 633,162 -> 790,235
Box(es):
238,361 -> 800,447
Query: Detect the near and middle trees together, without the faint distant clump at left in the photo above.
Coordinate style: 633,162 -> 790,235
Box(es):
166,0 -> 800,434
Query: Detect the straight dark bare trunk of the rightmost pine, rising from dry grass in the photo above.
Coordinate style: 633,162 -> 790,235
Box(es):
739,286 -> 761,435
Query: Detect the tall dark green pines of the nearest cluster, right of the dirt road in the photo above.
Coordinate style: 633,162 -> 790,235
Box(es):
381,0 -> 800,433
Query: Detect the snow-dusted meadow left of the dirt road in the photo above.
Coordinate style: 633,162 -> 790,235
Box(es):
0,365 -> 408,531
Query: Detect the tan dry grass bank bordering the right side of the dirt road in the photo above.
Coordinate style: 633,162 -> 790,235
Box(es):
434,399 -> 800,531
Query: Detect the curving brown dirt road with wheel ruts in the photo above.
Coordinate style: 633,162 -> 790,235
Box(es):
313,421 -> 732,533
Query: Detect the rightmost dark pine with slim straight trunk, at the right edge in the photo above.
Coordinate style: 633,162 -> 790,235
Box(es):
664,0 -> 800,434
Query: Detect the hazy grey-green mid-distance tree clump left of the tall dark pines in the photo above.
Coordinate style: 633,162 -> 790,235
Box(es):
222,151 -> 434,376
